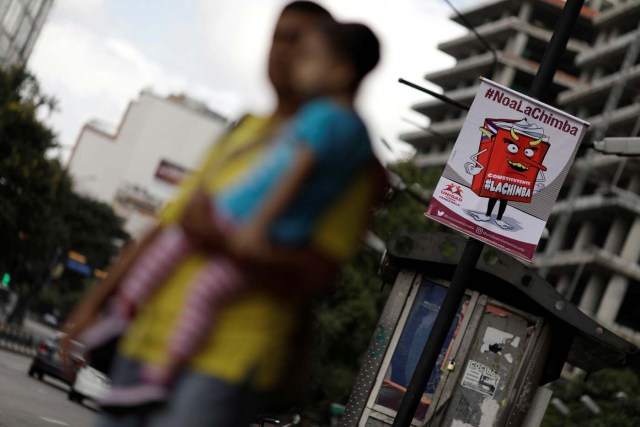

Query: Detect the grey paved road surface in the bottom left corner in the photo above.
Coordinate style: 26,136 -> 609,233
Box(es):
0,350 -> 95,427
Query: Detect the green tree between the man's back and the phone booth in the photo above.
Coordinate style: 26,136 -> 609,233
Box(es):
304,161 -> 442,423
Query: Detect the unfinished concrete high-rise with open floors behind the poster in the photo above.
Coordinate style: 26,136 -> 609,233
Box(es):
401,0 -> 640,344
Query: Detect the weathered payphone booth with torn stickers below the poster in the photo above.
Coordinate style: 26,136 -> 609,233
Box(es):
341,233 -> 637,427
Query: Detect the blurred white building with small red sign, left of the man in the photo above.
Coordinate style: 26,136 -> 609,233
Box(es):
67,91 -> 227,237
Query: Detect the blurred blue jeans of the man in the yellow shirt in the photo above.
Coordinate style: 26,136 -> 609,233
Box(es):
96,357 -> 269,427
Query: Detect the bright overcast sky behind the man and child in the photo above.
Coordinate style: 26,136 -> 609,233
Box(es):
28,0 -> 474,164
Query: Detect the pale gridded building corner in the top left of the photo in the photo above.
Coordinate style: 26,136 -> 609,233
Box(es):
0,0 -> 53,67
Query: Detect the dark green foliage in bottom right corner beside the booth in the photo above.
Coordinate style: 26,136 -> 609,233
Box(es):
542,369 -> 640,427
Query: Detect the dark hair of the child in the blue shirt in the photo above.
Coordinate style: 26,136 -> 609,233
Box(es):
321,20 -> 380,91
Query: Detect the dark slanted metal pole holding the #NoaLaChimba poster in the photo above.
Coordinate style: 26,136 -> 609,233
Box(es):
393,0 -> 584,427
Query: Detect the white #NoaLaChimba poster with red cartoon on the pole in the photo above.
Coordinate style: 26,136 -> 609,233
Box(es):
425,79 -> 589,261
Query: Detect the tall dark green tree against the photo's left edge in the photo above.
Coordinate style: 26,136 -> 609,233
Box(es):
0,68 -> 64,270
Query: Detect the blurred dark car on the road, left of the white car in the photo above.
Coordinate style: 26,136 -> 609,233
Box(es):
29,333 -> 85,385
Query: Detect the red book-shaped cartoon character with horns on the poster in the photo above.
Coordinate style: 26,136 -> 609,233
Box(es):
465,119 -> 550,230
